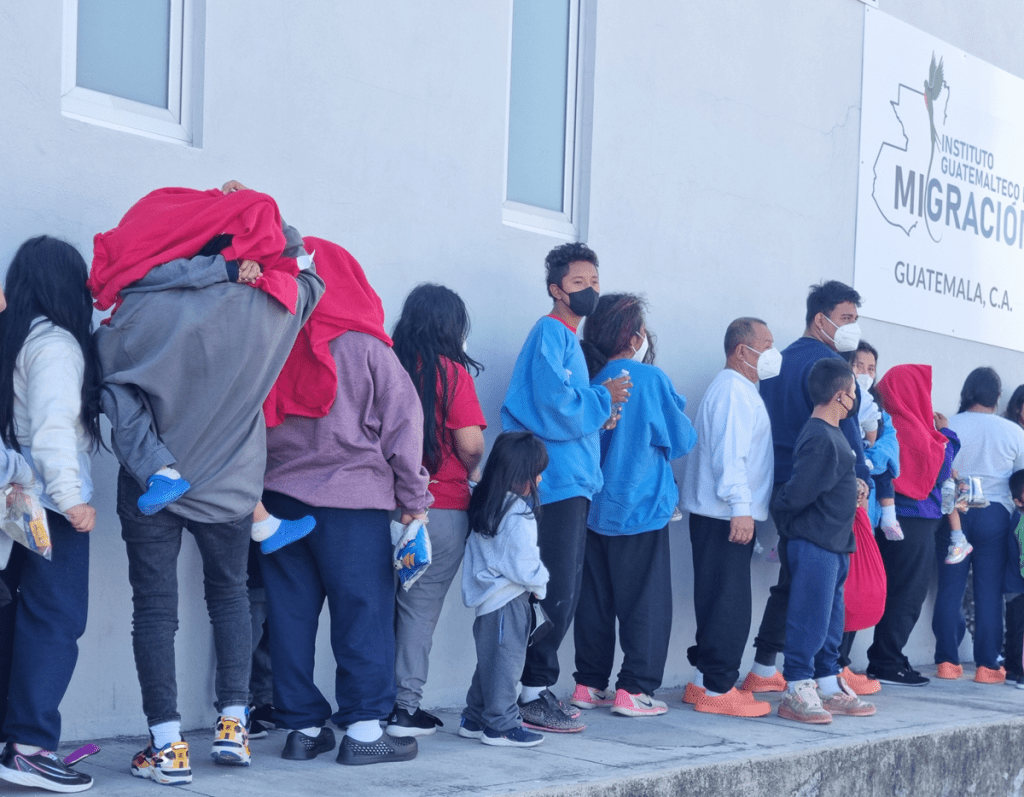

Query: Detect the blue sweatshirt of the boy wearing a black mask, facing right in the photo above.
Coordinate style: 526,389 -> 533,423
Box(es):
502,316 -> 611,504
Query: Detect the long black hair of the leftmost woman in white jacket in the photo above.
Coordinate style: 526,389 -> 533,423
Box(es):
0,236 -> 102,451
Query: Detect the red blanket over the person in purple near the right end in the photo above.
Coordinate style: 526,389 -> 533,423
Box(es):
879,365 -> 948,501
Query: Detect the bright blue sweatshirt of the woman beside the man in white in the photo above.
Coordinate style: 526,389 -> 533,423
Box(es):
585,360 -> 697,537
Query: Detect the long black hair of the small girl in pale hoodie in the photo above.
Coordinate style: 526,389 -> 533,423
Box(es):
468,431 -> 548,537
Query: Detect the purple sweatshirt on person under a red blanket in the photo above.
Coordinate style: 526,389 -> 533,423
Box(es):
264,332 -> 432,512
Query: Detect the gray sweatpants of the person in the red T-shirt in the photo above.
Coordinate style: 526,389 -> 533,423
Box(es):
394,509 -> 469,714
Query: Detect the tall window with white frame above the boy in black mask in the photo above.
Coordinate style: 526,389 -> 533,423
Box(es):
502,0 -> 593,240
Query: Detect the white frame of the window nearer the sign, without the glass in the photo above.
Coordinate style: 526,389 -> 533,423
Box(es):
502,0 -> 594,241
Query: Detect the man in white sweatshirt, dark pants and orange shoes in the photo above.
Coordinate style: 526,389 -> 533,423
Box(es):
681,318 -> 782,717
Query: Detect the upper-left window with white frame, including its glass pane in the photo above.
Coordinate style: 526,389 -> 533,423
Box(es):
60,0 -> 205,145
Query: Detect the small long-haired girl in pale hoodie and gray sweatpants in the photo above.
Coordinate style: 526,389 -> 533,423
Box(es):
459,431 -> 548,747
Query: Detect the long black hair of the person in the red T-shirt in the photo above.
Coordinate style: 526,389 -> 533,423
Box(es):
391,283 -> 483,473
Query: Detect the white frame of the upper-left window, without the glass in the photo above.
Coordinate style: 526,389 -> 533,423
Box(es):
60,0 -> 203,145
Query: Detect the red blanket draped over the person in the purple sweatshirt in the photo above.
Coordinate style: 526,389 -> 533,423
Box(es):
263,238 -> 391,426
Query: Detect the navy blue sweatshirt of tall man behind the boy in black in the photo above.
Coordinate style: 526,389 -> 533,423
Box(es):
761,337 -> 871,486
